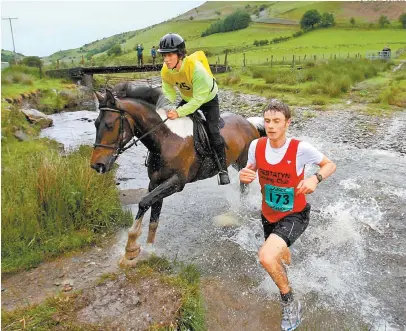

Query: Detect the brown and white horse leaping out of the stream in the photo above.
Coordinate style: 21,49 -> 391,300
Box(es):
91,85 -> 265,265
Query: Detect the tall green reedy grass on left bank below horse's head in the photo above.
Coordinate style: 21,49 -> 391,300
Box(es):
1,140 -> 132,273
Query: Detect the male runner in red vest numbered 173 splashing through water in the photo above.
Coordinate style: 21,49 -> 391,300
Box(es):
239,99 -> 336,331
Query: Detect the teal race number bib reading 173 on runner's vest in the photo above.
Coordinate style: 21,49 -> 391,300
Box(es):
265,184 -> 295,212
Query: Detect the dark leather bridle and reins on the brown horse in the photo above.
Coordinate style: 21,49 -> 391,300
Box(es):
93,107 -> 168,158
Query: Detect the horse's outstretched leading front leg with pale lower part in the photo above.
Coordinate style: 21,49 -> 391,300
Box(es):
121,175 -> 185,260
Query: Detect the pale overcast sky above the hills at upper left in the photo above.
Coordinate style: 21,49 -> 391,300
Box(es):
1,0 -> 205,56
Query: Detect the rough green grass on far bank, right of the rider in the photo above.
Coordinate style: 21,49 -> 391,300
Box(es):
217,59 -> 396,110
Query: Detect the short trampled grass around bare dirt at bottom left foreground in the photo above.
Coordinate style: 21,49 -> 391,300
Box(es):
1,256 -> 206,331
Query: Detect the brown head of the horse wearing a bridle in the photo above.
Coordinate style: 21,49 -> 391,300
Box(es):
90,90 -> 134,173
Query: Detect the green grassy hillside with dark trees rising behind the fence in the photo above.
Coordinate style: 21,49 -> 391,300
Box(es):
44,1 -> 406,66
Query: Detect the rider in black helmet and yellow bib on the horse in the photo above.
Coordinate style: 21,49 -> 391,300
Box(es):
158,33 -> 230,185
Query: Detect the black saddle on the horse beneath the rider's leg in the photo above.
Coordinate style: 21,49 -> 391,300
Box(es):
188,110 -> 228,157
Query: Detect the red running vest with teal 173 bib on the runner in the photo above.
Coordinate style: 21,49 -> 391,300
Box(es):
255,137 -> 306,223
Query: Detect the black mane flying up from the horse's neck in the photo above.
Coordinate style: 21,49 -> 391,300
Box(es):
113,82 -> 162,106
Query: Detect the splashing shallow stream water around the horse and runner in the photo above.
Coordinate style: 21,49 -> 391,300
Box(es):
38,107 -> 406,330
